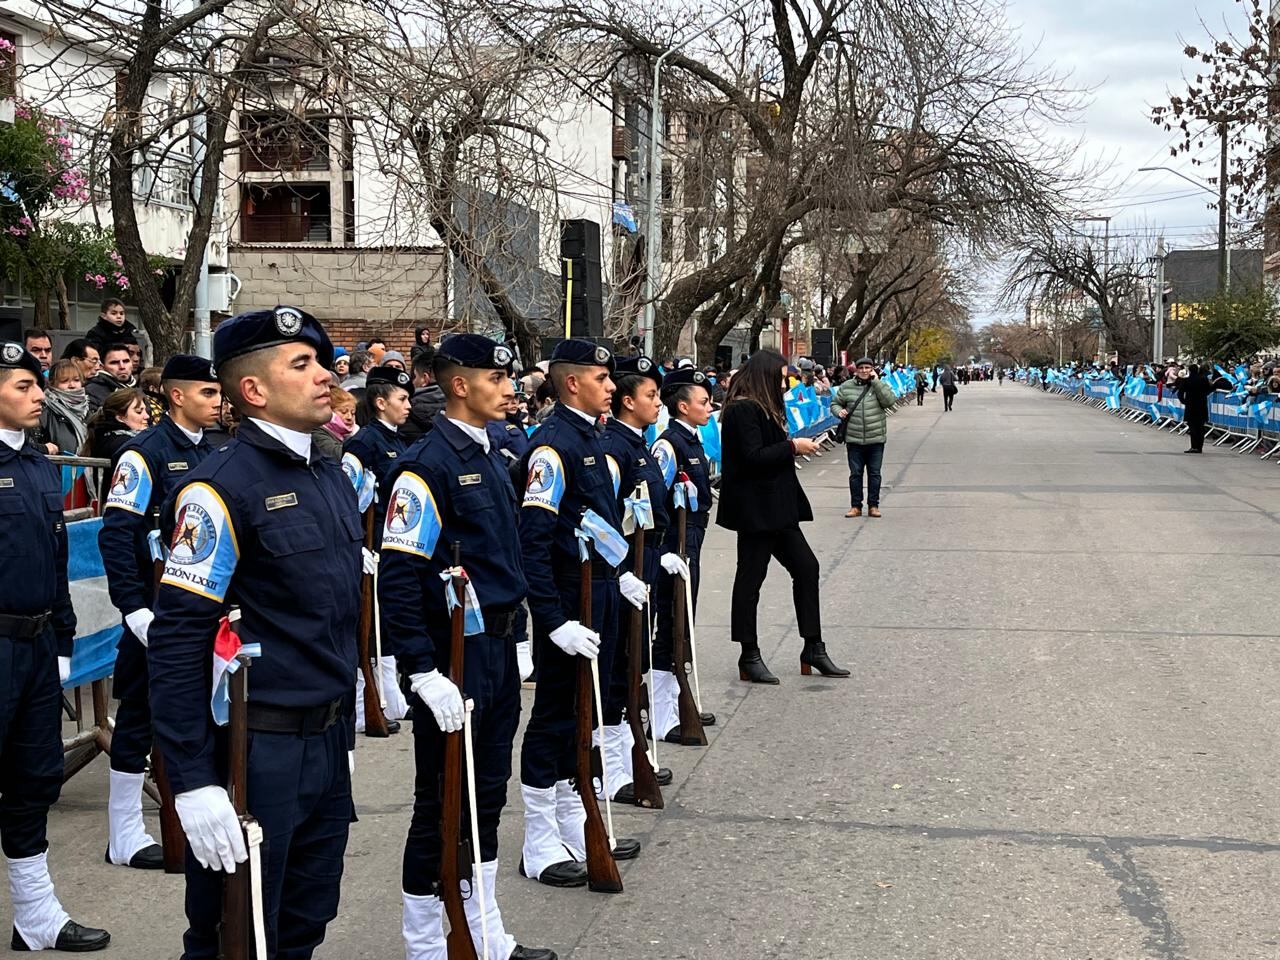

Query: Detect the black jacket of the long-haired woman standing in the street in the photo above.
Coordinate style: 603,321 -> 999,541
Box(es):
716,399 -> 813,532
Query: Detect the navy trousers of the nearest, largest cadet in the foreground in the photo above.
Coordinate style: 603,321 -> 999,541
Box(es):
183,721 -> 355,960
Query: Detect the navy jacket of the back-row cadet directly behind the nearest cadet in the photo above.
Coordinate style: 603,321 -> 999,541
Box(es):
97,416 -> 212,698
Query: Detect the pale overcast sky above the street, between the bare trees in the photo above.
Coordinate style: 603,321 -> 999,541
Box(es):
973,0 -> 1242,325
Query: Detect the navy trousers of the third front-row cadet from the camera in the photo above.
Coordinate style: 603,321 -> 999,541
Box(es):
519,577 -> 622,790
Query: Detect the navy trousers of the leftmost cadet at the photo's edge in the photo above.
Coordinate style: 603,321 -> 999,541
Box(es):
0,630 -> 63,860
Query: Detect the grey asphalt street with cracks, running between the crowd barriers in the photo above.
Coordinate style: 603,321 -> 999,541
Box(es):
50,384 -> 1280,960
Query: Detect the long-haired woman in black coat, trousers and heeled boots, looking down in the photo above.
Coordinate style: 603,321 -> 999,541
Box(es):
716,351 -> 849,684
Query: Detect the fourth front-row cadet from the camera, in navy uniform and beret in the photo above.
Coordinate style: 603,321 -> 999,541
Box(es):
596,356 -> 672,804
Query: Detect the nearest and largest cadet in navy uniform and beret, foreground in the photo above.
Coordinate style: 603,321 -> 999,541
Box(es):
147,306 -> 362,960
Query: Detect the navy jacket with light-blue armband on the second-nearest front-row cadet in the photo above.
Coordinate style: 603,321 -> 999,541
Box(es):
378,413 -> 526,675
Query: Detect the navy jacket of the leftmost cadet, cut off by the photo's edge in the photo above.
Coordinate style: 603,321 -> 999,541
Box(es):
0,440 -> 76,657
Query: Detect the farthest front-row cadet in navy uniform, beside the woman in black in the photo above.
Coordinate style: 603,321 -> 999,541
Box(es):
653,367 -> 716,744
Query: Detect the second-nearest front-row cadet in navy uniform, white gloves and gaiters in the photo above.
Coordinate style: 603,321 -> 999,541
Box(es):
379,334 -> 556,960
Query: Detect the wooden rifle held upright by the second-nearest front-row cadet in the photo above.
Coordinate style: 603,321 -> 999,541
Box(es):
438,543 -> 480,960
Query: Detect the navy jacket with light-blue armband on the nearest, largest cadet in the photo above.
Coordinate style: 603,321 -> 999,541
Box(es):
147,420 -> 364,794
